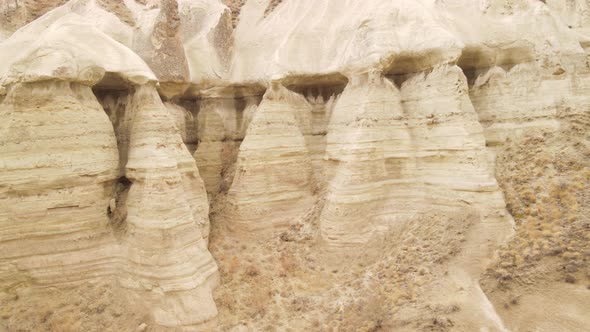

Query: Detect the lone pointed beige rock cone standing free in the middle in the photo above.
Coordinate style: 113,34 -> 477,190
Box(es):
225,82 -> 314,231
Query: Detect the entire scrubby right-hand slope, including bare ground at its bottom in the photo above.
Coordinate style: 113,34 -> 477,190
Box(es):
483,109 -> 590,331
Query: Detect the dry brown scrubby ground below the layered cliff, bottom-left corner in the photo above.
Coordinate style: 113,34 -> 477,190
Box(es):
0,280 -> 153,332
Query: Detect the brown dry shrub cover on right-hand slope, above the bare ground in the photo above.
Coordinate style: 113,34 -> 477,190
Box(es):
488,112 -> 590,286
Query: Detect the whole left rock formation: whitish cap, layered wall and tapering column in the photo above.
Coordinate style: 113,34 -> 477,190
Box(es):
0,1 -> 218,327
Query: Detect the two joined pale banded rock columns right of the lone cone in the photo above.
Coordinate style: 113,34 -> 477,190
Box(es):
321,66 -> 511,252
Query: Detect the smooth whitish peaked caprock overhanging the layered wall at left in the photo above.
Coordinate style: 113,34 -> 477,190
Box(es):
0,1 -> 156,85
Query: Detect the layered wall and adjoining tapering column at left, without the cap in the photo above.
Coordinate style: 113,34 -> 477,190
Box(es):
0,81 -> 217,326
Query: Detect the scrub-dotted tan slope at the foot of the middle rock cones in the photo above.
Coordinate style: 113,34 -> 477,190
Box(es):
210,214 -> 475,331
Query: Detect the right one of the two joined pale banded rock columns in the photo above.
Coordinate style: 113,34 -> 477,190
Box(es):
401,65 -> 511,264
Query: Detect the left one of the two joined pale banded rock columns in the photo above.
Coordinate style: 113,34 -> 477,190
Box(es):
320,71 -> 411,245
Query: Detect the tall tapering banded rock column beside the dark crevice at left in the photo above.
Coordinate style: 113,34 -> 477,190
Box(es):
121,86 -> 217,326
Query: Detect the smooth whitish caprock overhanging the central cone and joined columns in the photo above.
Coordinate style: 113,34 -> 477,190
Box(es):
231,0 -> 463,81
